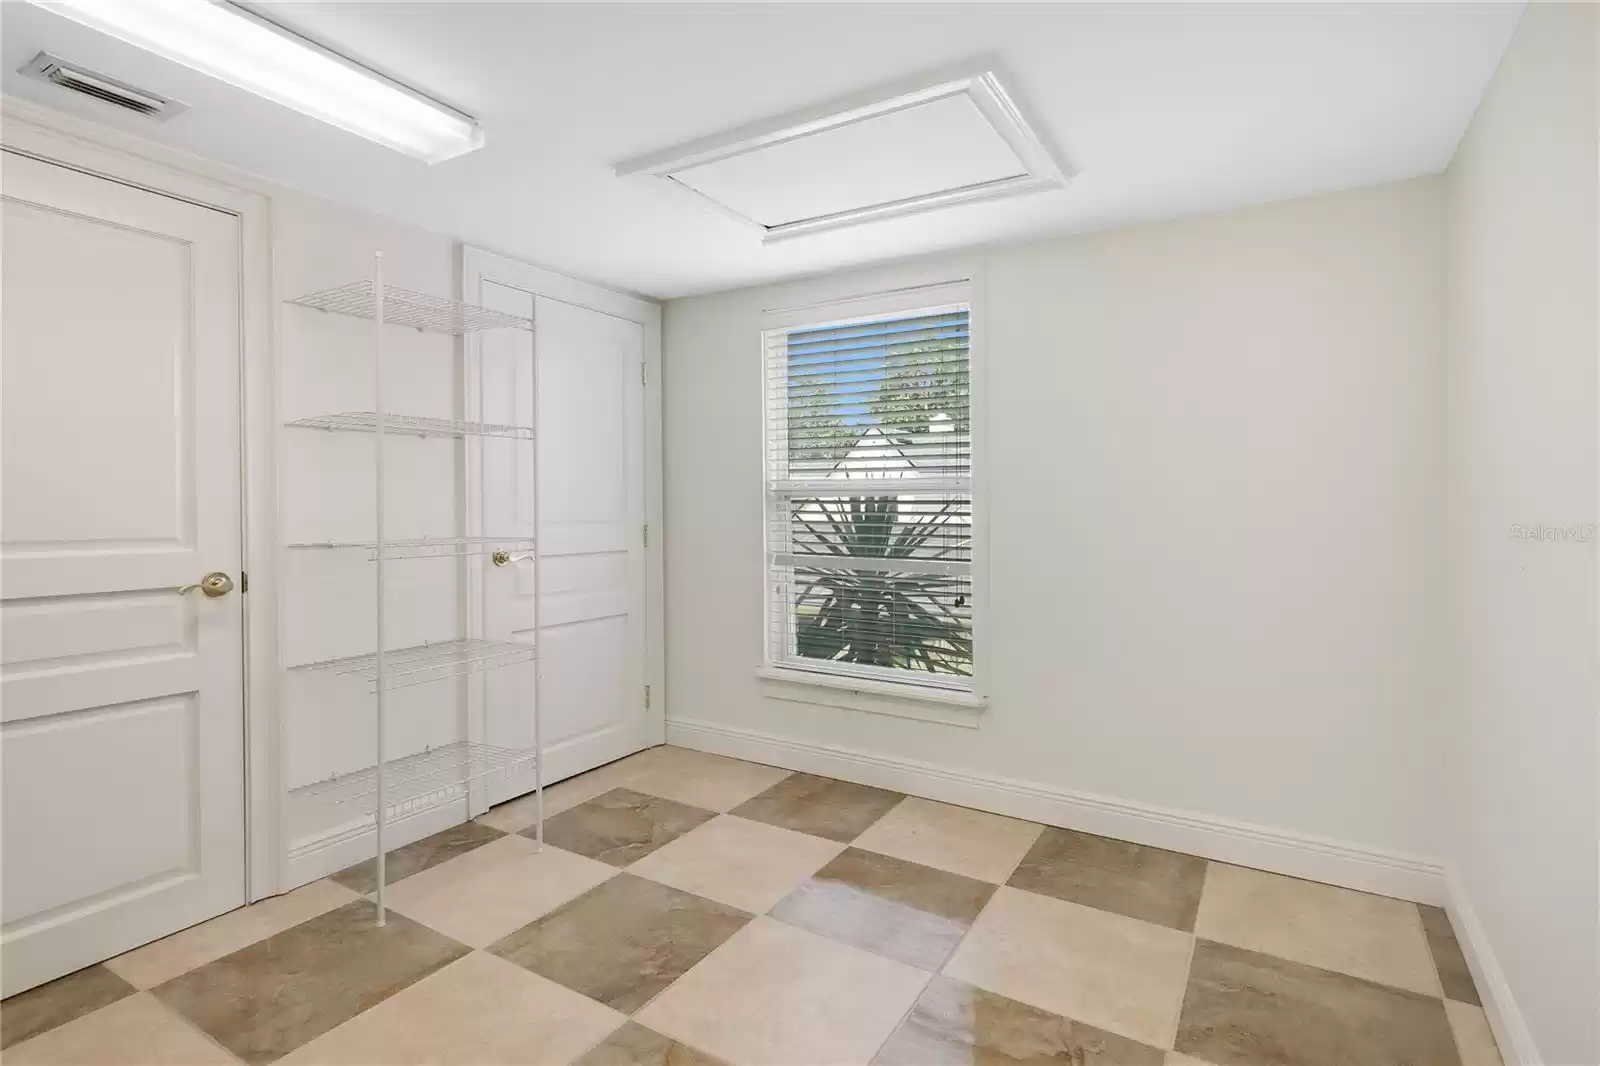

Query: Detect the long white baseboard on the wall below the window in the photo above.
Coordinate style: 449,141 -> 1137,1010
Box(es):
667,719 -> 1445,904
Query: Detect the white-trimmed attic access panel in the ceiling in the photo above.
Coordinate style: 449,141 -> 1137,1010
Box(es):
616,70 -> 1066,240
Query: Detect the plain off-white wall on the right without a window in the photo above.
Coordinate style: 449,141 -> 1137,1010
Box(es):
1445,3 -> 1600,1066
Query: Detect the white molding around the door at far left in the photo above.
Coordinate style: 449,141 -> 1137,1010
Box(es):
0,96 -> 283,903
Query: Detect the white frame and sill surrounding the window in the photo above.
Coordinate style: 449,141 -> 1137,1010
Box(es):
757,279 -> 989,710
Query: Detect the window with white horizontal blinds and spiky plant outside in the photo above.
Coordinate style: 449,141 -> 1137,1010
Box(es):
763,285 -> 973,695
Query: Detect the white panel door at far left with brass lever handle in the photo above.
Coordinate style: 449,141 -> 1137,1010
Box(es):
0,154 -> 245,996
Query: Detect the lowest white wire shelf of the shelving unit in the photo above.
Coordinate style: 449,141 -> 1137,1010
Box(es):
290,741 -> 538,821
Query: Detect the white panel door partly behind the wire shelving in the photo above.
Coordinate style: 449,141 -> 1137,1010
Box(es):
480,279 -> 649,804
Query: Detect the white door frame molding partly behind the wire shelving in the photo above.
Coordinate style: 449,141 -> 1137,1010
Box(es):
458,243 -> 667,771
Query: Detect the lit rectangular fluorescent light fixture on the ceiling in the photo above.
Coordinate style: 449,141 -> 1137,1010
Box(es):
34,0 -> 483,163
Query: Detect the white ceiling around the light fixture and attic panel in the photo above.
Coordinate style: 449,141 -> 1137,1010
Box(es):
0,0 -> 1522,298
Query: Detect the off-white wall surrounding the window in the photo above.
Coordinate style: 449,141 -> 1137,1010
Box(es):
664,179 -> 1443,895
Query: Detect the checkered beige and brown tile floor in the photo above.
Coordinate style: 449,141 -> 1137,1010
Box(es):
0,747 -> 1501,1066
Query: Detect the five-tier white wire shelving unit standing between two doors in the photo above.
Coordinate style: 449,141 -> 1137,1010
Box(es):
286,253 -> 544,925
